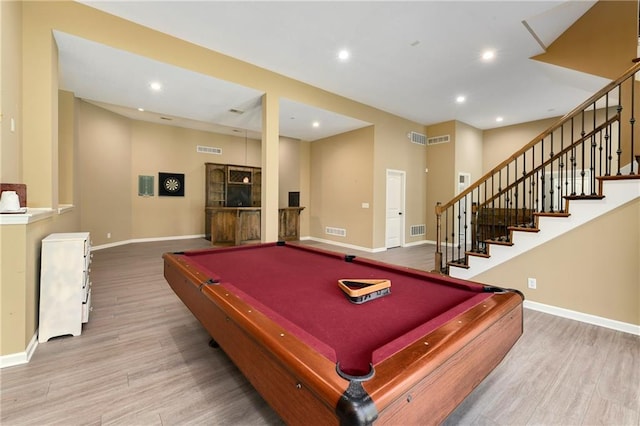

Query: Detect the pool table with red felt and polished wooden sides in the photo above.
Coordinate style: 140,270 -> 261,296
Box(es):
163,242 -> 523,425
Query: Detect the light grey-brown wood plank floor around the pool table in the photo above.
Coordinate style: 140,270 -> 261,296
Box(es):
0,240 -> 640,426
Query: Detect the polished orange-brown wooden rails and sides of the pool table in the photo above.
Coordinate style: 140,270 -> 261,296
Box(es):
163,254 -> 522,425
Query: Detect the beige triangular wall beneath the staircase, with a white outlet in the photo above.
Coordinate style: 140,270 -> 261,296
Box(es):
473,199 -> 640,325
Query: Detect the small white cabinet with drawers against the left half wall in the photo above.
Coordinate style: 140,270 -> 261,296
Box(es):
38,232 -> 91,343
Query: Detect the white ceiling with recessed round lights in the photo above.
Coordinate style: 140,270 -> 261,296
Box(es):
55,0 -> 608,140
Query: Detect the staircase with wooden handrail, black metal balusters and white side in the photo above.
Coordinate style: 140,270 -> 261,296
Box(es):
434,63 -> 640,279
